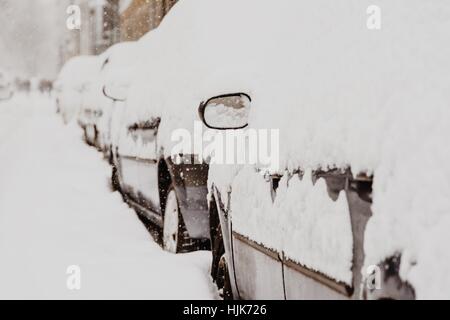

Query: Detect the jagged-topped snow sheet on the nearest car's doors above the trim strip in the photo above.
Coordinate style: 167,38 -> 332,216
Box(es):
230,167 -> 353,285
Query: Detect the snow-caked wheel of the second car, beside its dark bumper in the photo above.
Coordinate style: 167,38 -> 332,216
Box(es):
163,187 -> 191,253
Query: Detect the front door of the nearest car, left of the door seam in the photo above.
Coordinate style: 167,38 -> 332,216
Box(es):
230,167 -> 285,300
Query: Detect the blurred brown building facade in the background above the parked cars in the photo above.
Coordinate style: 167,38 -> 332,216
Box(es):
59,0 -> 178,65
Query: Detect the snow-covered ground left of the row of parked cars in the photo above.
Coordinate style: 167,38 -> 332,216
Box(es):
0,96 -> 216,299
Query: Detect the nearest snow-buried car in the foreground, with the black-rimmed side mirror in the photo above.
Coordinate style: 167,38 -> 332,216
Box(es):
191,0 -> 450,299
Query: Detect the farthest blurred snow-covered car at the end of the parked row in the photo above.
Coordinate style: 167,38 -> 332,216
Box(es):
54,56 -> 99,123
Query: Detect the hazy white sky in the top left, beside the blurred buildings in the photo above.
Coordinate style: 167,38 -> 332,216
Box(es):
0,0 -> 66,77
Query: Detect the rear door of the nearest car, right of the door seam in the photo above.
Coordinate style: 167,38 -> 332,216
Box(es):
277,171 -> 354,300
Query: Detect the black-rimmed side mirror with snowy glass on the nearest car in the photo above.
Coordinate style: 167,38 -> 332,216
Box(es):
198,93 -> 252,130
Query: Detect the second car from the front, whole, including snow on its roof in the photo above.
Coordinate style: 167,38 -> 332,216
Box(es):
105,11 -> 215,253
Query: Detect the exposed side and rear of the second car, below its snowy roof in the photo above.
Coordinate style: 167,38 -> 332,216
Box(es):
113,102 -> 209,253
